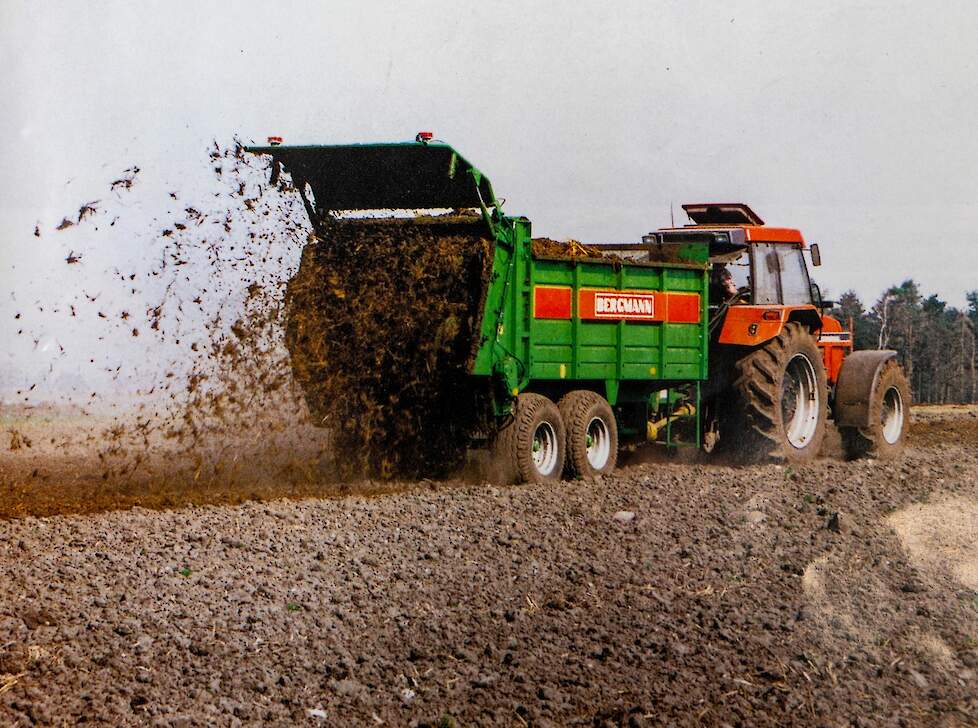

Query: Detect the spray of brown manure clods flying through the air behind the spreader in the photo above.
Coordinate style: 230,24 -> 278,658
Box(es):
0,140 -> 337,519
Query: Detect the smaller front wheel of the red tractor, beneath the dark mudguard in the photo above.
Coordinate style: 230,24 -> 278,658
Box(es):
839,359 -> 911,460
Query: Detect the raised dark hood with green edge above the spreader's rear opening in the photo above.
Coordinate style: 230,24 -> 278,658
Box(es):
246,142 -> 496,214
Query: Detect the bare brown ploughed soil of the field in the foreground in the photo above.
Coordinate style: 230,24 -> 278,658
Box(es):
0,408 -> 978,726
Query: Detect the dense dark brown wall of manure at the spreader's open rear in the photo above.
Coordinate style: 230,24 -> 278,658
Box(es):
286,221 -> 492,478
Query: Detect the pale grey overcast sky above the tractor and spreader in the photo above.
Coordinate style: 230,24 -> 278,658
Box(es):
0,0 -> 978,396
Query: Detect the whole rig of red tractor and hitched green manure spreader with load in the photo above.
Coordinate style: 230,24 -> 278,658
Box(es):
248,133 -> 910,481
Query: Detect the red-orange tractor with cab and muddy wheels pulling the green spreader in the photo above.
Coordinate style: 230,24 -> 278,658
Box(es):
644,203 -> 910,462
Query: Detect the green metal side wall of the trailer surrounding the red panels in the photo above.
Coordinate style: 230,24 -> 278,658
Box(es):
472,217 -> 708,410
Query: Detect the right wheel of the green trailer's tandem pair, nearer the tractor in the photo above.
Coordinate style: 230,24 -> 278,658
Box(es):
557,389 -> 618,478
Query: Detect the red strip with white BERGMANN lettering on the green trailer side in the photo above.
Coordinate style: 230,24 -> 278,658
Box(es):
533,286 -> 700,324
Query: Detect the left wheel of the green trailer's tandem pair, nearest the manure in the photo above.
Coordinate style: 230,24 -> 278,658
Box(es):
492,392 -> 567,483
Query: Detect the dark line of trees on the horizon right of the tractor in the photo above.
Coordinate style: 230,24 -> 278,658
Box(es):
829,280 -> 978,404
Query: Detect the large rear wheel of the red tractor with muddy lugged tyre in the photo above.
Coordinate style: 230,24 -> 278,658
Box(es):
720,322 -> 829,463
